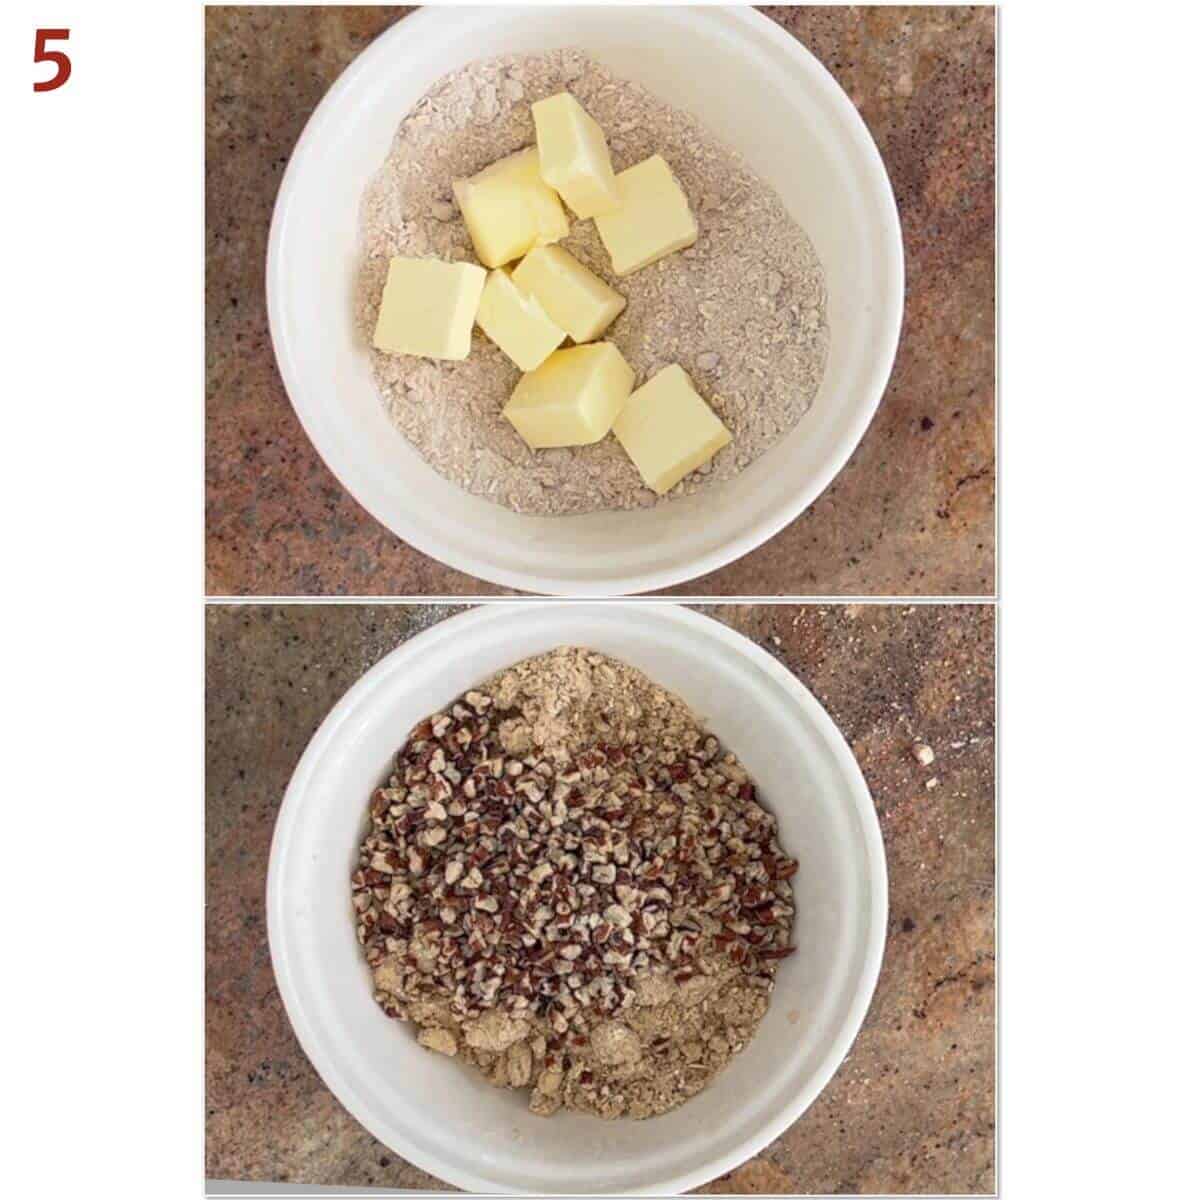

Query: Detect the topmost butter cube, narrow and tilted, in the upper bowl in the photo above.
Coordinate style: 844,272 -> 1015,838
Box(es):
533,91 -> 620,217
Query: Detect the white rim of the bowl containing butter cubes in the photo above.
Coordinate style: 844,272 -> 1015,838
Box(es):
265,7 -> 905,596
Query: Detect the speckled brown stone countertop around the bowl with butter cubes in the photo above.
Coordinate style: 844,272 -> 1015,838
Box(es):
205,7 -> 995,595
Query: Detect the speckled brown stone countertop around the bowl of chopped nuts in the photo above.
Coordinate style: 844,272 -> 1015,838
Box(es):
205,605 -> 995,1194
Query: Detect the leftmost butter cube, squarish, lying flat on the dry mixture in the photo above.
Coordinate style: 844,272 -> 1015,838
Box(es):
374,258 -> 487,359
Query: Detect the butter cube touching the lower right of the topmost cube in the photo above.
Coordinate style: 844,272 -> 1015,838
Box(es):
596,154 -> 697,275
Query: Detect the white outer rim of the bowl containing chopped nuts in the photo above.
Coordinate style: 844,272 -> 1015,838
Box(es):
265,600 -> 888,1195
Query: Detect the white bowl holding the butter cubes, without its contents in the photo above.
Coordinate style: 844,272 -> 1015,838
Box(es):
266,7 -> 904,595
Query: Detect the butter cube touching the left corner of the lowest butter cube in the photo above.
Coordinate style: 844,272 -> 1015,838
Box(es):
504,342 -> 634,450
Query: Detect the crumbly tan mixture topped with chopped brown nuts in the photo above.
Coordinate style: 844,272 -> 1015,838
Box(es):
352,647 -> 796,1118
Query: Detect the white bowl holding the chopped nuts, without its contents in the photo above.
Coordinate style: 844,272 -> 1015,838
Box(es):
266,602 -> 887,1194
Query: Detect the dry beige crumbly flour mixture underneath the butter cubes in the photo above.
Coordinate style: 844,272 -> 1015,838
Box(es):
358,49 -> 828,514
